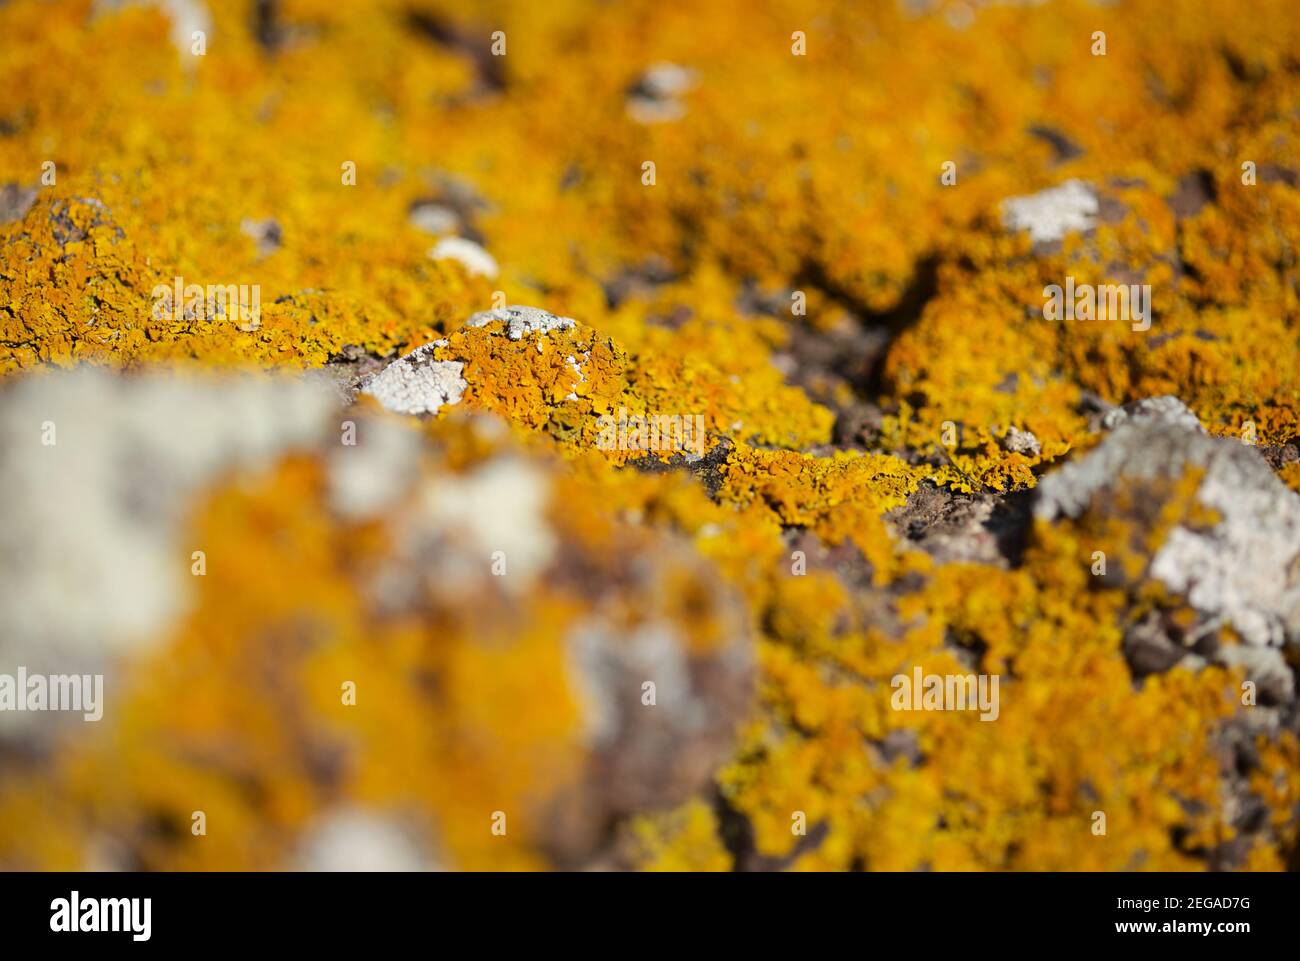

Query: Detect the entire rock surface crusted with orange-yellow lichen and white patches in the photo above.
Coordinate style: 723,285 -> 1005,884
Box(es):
0,0 -> 1300,871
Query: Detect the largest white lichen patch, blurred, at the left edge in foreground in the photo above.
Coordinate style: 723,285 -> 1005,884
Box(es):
0,368 -> 337,697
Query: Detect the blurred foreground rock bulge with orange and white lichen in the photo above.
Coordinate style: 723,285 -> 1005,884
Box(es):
0,369 -> 754,870
